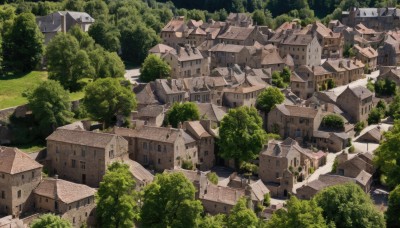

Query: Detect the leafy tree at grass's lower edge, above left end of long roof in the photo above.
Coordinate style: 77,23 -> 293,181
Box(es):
27,80 -> 73,136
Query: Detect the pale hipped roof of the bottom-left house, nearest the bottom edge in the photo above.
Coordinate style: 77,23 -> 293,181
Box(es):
33,178 -> 96,204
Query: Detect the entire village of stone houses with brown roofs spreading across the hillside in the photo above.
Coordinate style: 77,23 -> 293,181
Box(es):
0,3 -> 400,227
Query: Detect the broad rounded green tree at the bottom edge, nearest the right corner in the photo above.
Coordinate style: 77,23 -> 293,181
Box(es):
315,183 -> 385,228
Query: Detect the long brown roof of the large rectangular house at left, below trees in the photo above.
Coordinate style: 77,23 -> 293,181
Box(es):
46,129 -> 116,148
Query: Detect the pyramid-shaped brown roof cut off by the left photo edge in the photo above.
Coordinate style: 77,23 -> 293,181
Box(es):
0,146 -> 43,175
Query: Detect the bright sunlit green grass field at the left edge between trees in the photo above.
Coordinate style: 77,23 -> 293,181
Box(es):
0,71 -> 84,109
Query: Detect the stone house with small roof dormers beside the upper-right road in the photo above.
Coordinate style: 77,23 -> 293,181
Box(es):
322,59 -> 365,86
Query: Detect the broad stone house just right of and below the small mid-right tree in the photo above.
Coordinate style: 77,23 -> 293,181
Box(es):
267,104 -> 322,140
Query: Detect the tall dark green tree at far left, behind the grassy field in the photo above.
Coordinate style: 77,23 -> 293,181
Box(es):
3,13 -> 43,72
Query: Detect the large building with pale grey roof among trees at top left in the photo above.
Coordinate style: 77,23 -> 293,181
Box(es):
36,11 -> 94,44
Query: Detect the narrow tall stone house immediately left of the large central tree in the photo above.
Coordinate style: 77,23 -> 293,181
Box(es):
182,120 -> 216,170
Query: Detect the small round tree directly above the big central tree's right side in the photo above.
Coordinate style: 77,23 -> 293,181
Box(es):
256,86 -> 285,114
